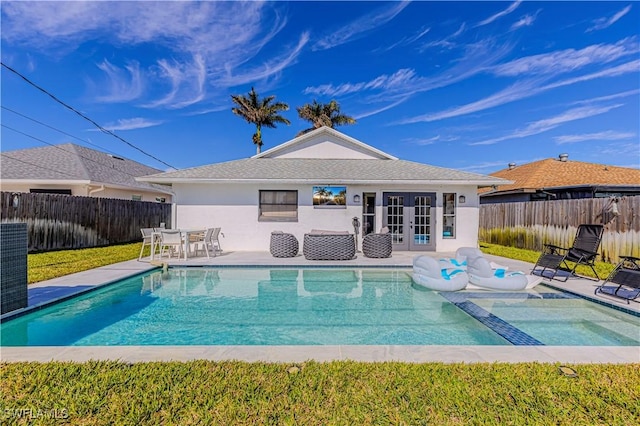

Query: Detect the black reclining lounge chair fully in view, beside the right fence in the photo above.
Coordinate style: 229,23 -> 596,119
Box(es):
531,224 -> 604,281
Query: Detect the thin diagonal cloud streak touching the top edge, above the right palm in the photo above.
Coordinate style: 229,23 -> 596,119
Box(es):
313,0 -> 409,50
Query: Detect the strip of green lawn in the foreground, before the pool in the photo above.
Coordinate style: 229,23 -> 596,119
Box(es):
0,361 -> 640,425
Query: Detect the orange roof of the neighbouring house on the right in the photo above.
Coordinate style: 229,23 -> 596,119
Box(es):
479,158 -> 640,193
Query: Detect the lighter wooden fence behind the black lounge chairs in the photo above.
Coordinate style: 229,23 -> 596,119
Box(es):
479,196 -> 640,263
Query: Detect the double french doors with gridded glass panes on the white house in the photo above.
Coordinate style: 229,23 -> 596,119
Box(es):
382,192 -> 436,251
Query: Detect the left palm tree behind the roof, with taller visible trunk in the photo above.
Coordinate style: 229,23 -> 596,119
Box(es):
231,87 -> 291,154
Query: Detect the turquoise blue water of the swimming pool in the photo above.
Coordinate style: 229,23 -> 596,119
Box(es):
0,268 -> 640,346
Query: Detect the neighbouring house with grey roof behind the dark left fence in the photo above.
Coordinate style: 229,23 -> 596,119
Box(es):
0,143 -> 172,202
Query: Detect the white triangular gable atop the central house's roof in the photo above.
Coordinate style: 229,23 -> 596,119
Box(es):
252,126 -> 397,160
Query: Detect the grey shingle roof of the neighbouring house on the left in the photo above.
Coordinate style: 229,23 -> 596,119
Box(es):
0,143 -> 171,194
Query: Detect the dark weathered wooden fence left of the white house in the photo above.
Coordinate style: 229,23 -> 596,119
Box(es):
0,192 -> 171,252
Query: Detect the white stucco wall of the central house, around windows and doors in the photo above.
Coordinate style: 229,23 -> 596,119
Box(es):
172,183 -> 479,252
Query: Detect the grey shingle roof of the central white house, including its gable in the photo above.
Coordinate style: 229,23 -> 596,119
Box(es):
138,127 -> 506,186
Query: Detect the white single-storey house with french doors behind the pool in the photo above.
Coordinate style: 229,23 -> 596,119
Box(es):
138,127 -> 507,251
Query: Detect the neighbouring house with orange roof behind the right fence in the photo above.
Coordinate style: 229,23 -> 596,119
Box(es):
480,154 -> 640,204
